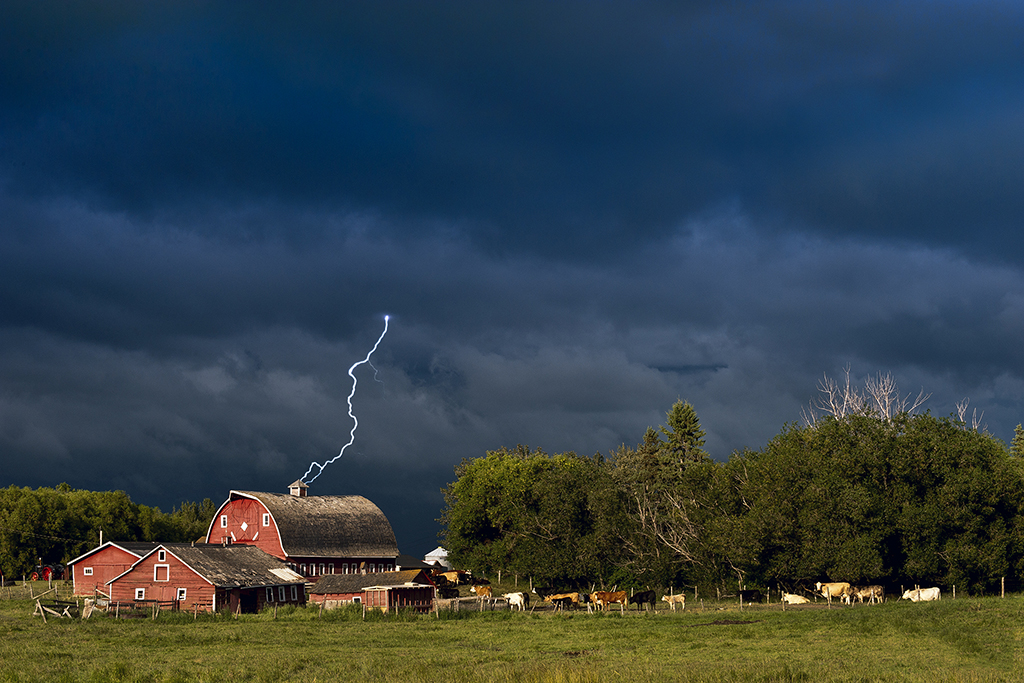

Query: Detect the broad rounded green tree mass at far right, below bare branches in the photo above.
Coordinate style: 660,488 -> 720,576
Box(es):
730,414 -> 1024,592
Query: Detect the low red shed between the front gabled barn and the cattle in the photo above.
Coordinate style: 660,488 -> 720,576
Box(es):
309,569 -> 436,612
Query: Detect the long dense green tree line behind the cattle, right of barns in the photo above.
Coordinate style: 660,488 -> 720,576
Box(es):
440,401 -> 1024,594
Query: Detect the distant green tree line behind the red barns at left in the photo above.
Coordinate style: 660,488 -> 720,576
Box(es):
0,483 -> 217,578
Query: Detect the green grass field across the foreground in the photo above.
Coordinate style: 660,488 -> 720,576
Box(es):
0,581 -> 1024,683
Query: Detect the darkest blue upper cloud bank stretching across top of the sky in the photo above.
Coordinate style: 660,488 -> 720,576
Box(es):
2,2 -> 1024,256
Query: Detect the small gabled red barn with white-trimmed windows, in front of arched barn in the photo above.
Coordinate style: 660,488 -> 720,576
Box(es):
108,544 -> 306,612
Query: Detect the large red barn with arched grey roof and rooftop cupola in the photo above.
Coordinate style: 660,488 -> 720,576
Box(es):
206,481 -> 398,581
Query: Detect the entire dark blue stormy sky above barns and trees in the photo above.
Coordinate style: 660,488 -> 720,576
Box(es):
0,0 -> 1024,555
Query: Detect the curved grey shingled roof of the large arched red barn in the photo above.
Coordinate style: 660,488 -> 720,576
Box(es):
230,490 -> 398,558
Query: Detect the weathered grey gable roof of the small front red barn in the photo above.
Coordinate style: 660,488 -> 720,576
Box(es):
165,544 -> 304,588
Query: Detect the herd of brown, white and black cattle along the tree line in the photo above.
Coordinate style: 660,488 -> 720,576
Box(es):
433,570 -> 941,611
